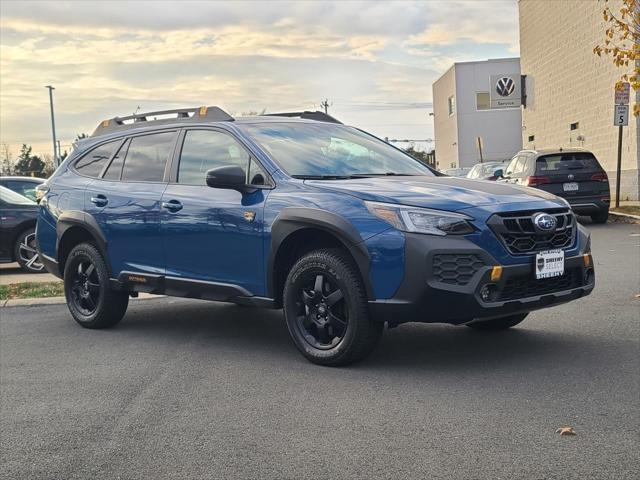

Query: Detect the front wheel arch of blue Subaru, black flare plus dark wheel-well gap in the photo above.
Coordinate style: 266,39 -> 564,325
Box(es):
267,208 -> 374,306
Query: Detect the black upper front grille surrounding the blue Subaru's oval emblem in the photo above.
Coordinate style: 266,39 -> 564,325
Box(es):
487,209 -> 576,255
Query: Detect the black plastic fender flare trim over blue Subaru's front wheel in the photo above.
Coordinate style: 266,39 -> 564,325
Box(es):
267,207 -> 374,299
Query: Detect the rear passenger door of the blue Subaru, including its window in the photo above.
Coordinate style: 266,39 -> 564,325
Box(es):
85,130 -> 178,276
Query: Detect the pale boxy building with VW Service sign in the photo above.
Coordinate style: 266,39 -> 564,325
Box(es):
433,58 -> 522,170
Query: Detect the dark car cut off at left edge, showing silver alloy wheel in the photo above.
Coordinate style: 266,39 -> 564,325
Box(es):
0,186 -> 44,273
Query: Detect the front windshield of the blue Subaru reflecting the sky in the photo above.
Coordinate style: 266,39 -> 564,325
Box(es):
245,123 -> 433,178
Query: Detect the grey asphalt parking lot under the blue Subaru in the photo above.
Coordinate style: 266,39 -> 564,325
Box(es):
0,224 -> 640,479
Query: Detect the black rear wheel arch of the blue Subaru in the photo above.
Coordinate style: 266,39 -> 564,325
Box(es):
56,211 -> 111,275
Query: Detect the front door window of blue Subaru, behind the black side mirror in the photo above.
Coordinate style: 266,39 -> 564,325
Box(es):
178,130 -> 252,185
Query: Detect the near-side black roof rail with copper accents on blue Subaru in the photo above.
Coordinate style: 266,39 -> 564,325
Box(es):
91,107 -> 234,137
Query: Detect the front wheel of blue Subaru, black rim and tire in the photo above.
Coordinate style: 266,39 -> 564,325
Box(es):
283,249 -> 384,367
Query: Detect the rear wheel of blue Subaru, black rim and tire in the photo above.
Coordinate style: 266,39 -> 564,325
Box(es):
64,243 -> 129,328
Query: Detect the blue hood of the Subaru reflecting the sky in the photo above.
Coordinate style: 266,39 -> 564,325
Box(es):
305,176 -> 567,211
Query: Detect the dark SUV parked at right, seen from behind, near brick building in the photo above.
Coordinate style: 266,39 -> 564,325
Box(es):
503,149 -> 611,223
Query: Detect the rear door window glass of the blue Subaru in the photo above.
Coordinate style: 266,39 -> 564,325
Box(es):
122,132 -> 176,182
